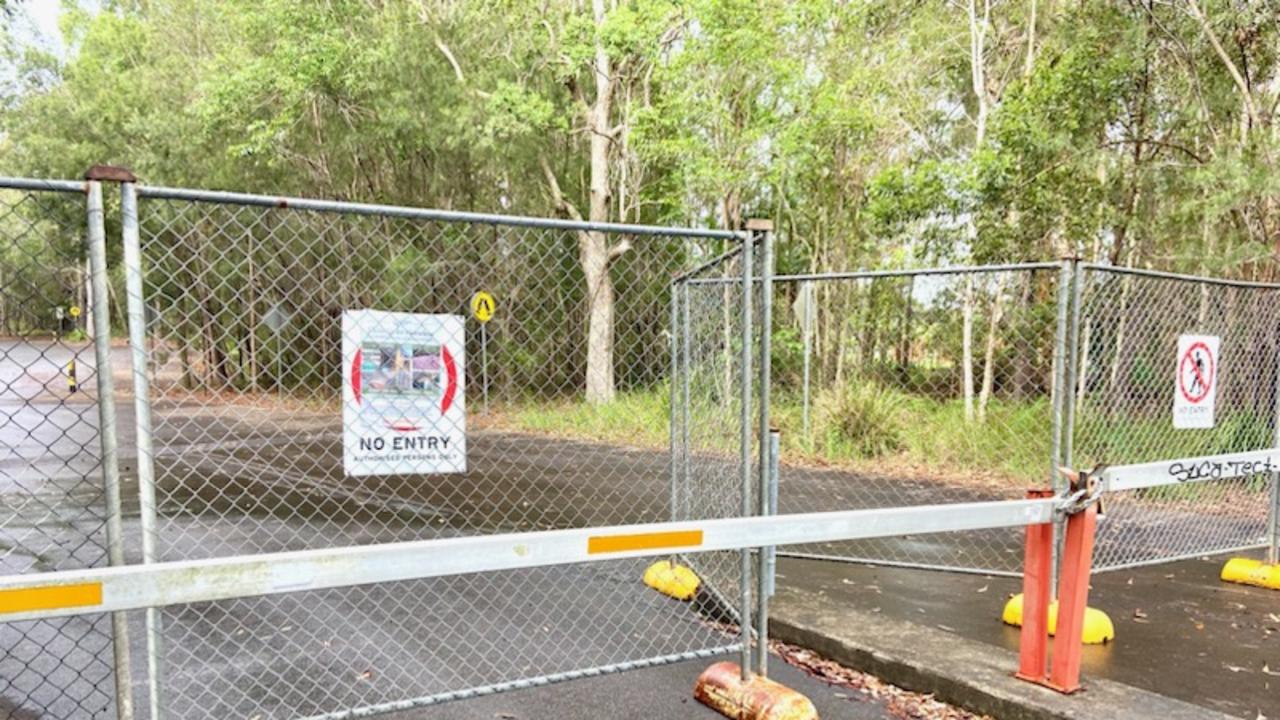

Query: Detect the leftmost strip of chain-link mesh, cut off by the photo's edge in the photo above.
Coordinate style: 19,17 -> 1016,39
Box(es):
0,183 -> 115,719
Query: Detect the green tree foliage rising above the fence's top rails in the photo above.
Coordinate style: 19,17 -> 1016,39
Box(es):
0,0 -> 1280,279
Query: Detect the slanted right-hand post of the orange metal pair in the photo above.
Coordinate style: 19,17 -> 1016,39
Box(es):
1048,505 -> 1098,693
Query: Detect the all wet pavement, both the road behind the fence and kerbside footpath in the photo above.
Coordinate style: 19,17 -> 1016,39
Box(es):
0,333 -> 1280,720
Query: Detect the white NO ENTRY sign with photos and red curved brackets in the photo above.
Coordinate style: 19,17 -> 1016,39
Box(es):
342,310 -> 467,475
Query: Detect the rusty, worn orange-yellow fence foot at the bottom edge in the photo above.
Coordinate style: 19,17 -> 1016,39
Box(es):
694,662 -> 818,720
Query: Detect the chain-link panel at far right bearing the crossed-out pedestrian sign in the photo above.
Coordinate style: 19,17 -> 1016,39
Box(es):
1066,264 -> 1280,570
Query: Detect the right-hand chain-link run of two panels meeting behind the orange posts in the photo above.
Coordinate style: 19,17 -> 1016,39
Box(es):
757,263 -> 1280,574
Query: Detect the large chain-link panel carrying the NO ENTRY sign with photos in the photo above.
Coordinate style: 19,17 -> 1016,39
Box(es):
124,186 -> 751,717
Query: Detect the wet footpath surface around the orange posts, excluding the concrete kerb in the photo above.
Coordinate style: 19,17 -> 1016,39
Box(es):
778,545 -> 1280,720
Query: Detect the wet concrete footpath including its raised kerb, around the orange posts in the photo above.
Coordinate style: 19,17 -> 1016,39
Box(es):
771,557 -> 1280,720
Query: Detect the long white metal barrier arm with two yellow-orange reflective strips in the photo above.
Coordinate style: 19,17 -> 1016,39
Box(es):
0,497 -> 1061,623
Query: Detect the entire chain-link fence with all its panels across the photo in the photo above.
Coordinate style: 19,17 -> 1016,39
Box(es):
10,166 -> 1280,717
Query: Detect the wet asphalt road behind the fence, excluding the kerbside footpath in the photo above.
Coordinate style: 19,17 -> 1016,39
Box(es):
0,341 -> 1280,720
